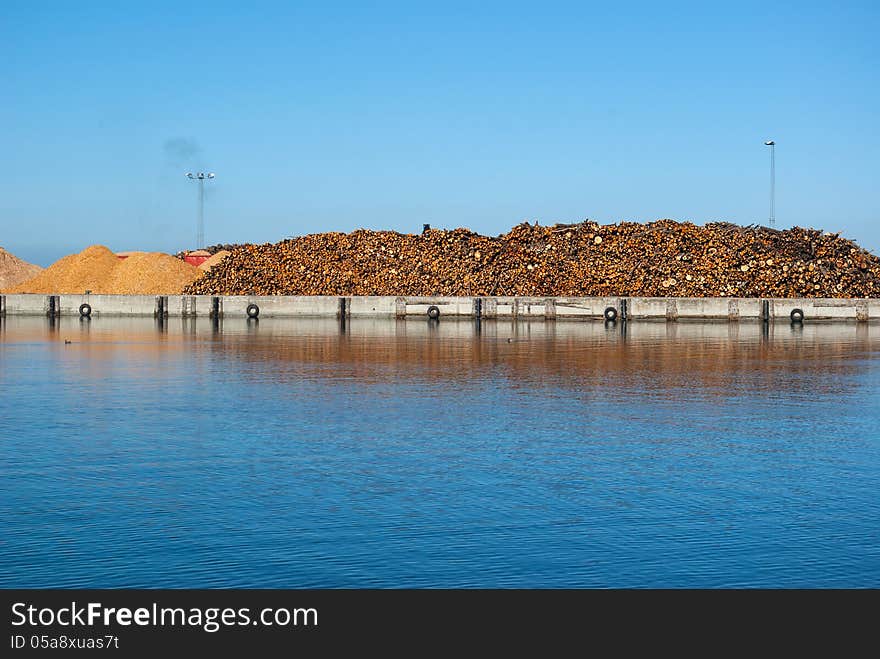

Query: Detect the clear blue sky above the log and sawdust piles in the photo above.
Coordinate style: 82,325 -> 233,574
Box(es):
0,0 -> 880,265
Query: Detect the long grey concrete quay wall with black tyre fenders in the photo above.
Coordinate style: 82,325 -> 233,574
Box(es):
0,294 -> 880,322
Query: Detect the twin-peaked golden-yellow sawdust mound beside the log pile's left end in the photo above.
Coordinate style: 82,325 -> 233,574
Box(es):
5,245 -> 203,295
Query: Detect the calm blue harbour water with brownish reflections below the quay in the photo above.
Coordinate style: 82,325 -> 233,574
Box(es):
0,318 -> 880,588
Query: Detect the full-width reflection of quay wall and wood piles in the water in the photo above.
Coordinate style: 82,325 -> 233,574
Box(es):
0,317 -> 880,408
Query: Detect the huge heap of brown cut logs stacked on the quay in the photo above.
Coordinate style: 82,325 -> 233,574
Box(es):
185,220 -> 880,297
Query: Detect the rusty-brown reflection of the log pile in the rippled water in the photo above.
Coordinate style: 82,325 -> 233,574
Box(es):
209,323 -> 878,399
